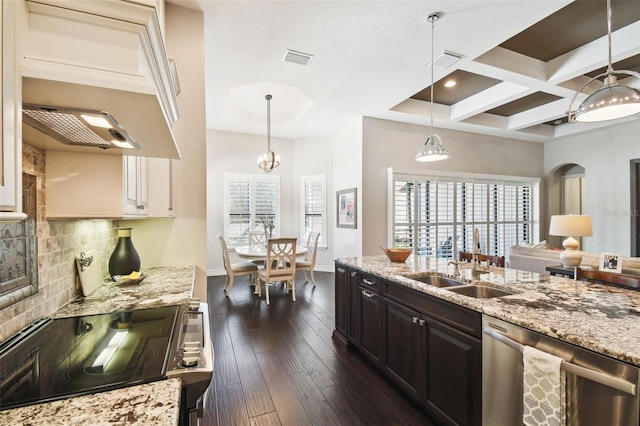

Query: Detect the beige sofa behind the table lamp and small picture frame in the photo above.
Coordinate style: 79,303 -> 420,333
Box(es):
506,241 -> 640,275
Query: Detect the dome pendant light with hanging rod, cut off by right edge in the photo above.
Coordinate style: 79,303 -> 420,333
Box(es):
569,0 -> 640,123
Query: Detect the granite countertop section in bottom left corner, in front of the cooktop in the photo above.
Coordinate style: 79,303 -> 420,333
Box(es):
0,378 -> 182,426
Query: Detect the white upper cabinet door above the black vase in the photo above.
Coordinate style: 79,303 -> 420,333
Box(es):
122,156 -> 149,216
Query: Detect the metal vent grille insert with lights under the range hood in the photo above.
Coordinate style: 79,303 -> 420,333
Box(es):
22,104 -> 140,149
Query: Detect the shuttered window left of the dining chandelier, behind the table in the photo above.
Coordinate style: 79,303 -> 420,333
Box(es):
224,173 -> 280,247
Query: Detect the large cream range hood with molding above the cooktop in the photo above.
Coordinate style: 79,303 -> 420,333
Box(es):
22,0 -> 180,159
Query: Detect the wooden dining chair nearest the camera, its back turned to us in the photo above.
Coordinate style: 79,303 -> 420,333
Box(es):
256,238 -> 297,305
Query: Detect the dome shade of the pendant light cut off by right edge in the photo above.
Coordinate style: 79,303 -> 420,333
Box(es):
574,75 -> 640,123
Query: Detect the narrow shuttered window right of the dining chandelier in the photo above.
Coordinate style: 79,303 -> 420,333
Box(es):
300,175 -> 327,247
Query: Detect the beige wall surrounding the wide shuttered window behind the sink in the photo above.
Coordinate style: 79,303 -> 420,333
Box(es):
362,118 -> 546,255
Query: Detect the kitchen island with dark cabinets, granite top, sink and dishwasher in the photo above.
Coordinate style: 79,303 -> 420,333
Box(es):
333,256 -> 640,426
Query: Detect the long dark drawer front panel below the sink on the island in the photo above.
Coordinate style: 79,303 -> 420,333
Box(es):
384,281 -> 482,338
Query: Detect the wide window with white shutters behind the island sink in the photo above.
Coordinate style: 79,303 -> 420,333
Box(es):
389,169 -> 539,258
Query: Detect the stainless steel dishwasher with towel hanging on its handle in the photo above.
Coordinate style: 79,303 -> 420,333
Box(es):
482,315 -> 640,426
